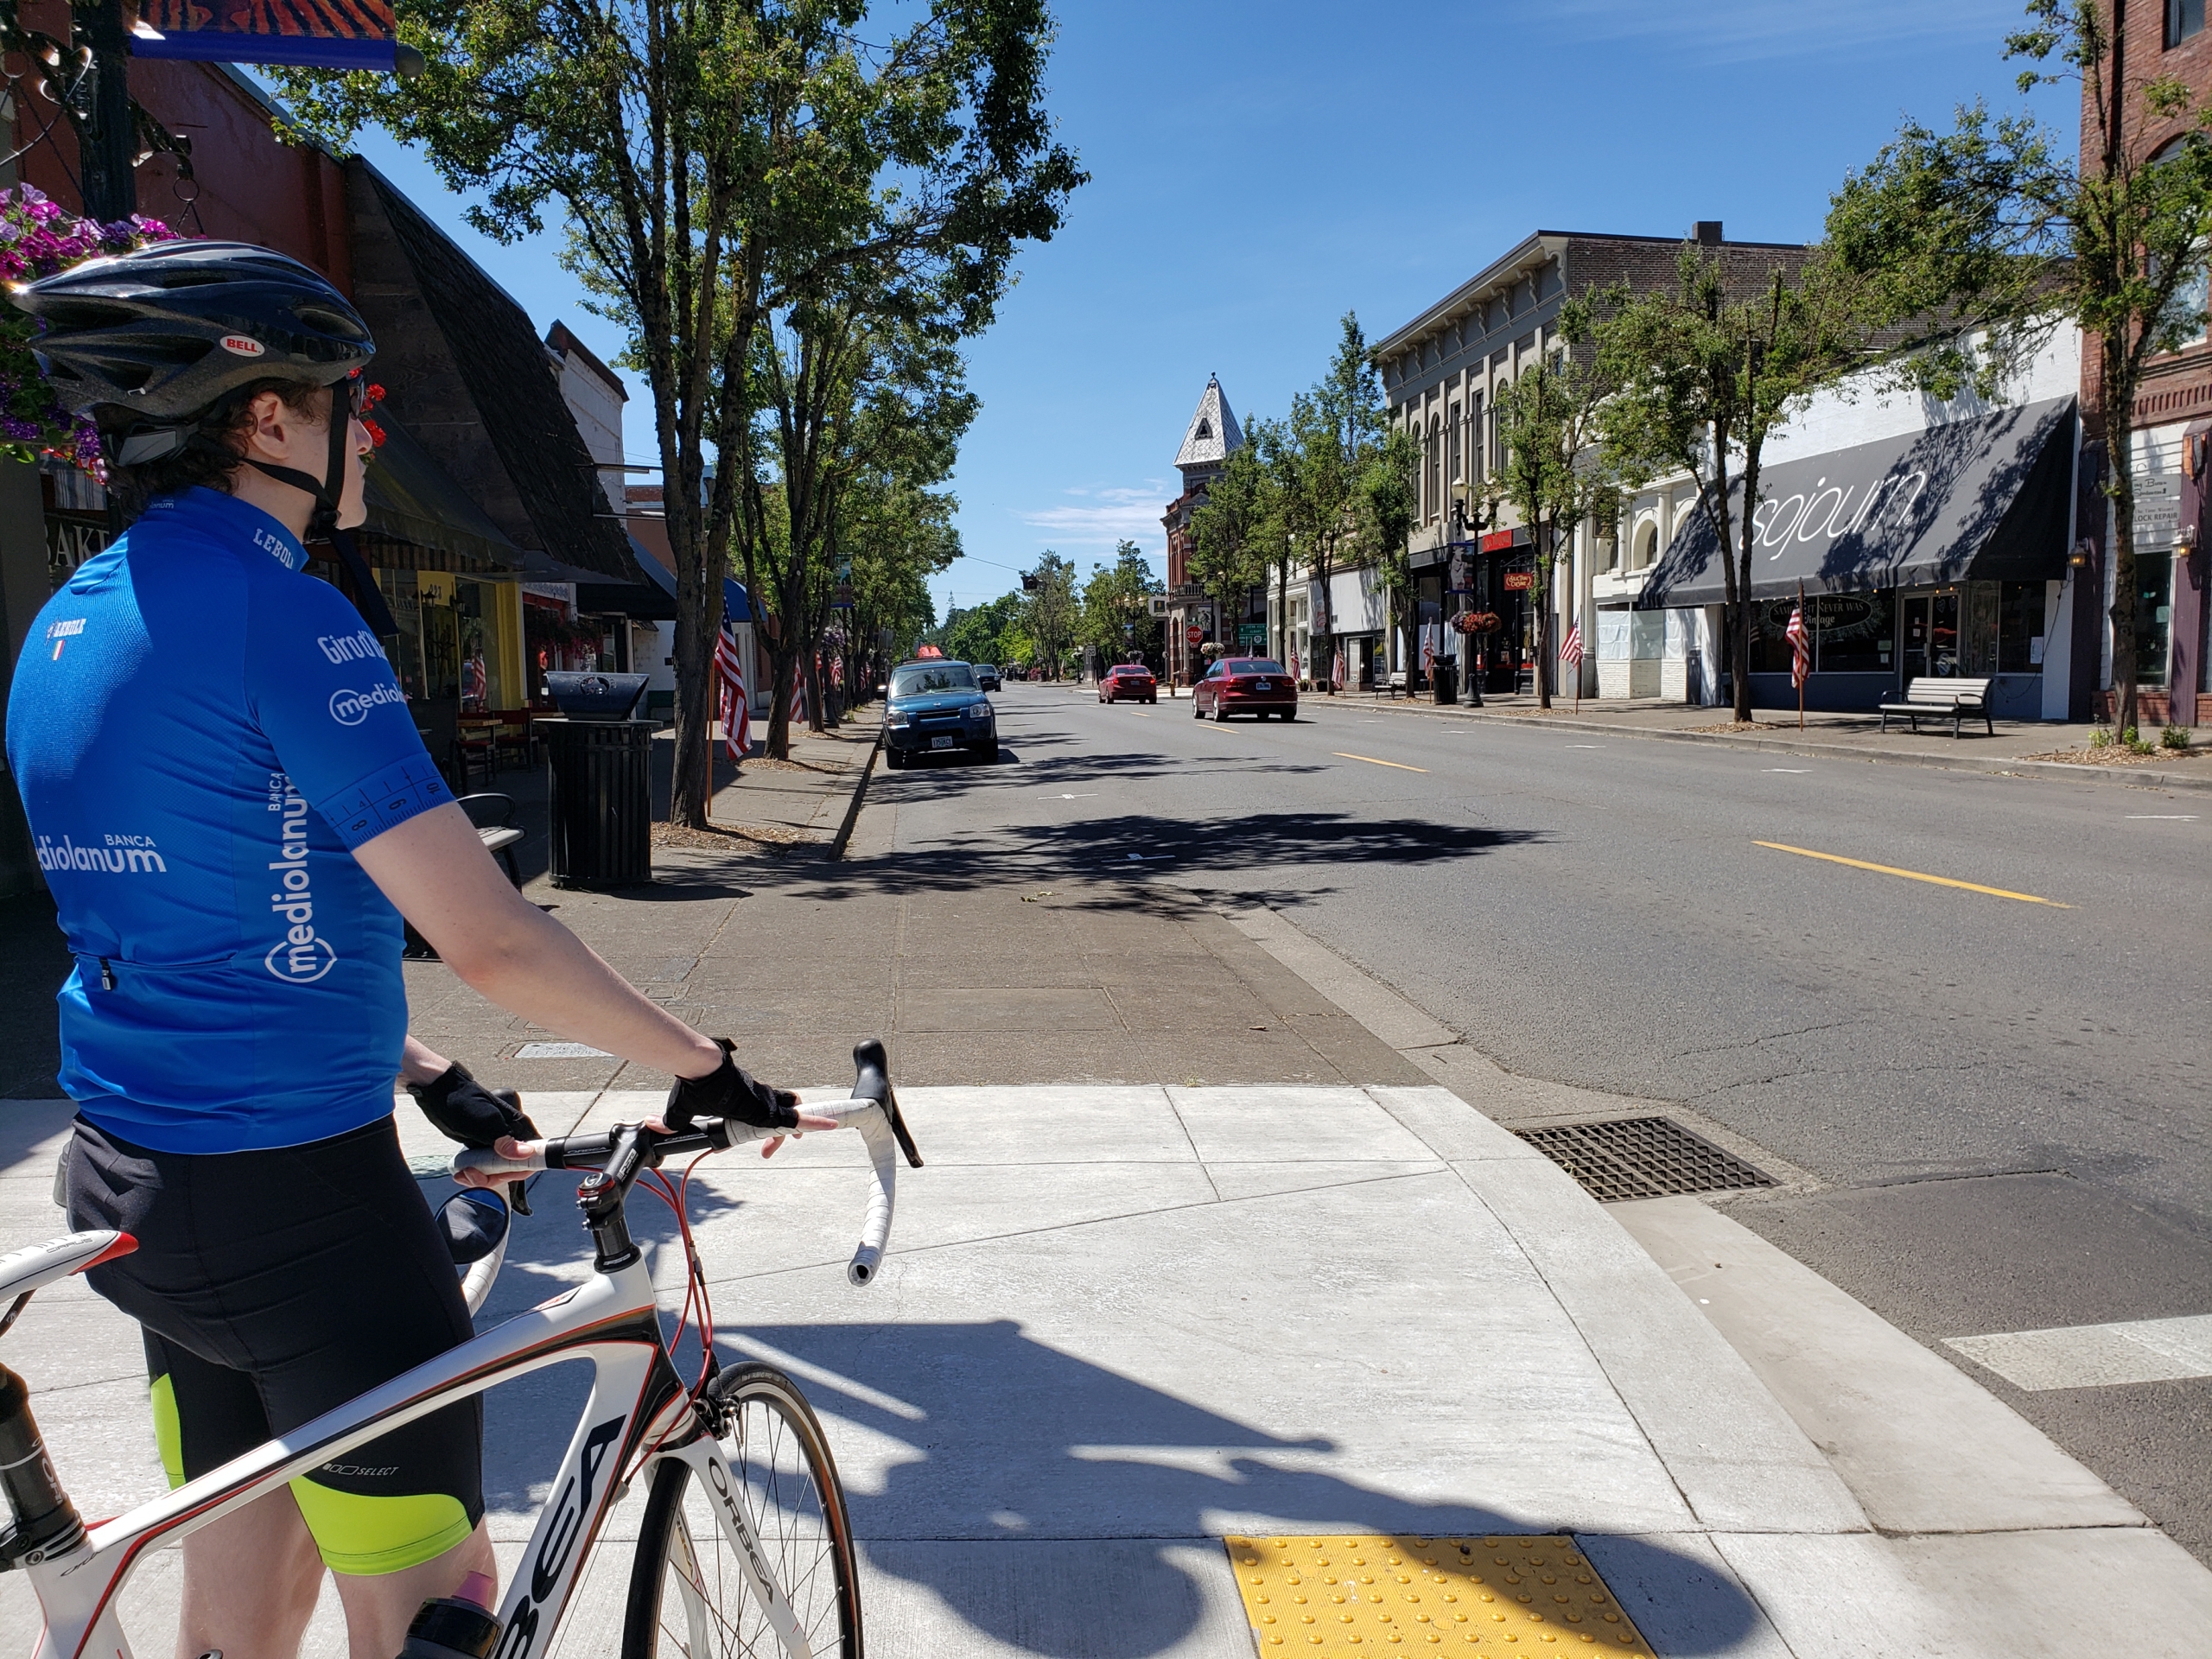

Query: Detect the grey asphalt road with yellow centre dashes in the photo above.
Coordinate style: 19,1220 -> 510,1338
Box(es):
874,686 -> 2212,1560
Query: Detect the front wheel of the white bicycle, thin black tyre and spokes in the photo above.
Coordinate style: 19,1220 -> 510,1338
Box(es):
621,1363 -> 861,1659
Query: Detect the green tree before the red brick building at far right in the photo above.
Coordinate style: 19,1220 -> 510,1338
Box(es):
1827,0 -> 2212,728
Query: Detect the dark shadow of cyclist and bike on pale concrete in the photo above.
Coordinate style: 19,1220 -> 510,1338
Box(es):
743,1320 -> 1757,1659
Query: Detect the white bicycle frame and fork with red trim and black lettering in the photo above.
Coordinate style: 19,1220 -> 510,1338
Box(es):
22,1221 -> 831,1659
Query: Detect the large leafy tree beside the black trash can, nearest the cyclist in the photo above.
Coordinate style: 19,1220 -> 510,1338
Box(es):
279,0 -> 1084,825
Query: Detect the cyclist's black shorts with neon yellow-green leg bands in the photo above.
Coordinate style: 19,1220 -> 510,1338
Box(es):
67,1117 -> 485,1575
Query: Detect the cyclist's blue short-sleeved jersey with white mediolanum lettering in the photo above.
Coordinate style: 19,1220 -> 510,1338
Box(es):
7,489 -> 454,1153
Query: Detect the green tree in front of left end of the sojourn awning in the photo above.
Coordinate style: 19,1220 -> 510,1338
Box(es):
1592,241 -> 1878,721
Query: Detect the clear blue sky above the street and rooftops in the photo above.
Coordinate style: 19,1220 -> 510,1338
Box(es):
336,0 -> 2075,617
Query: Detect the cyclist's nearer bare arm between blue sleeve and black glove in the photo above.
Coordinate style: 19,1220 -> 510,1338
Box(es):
354,805 -> 721,1092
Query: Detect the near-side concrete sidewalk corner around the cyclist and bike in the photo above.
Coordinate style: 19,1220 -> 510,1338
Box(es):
0,765 -> 2212,1659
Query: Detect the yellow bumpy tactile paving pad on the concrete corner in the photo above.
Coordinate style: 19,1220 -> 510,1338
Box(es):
1224,1533 -> 1652,1659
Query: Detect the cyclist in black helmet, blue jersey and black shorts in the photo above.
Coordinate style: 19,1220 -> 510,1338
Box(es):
7,241 -> 832,1659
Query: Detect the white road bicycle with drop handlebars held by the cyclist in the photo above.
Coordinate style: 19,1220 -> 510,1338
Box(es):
0,1039 -> 923,1659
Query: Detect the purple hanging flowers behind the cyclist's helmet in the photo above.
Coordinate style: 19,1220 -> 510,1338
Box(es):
0,183 -> 177,485
